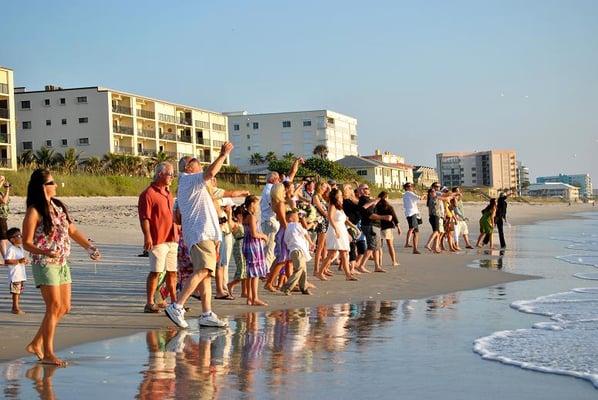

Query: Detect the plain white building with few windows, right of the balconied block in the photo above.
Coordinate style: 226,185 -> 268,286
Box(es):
226,110 -> 357,168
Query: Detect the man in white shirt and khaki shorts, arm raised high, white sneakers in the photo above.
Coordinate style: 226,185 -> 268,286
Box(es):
165,142 -> 238,328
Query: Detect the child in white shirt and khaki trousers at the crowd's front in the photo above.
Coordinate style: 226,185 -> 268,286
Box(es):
281,209 -> 313,295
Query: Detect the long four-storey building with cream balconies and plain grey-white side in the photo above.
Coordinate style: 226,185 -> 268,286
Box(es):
15,86 -> 228,163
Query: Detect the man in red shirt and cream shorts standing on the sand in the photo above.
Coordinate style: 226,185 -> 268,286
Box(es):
138,162 -> 178,313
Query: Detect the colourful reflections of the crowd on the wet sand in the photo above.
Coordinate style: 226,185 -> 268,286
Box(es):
1,295 -> 458,400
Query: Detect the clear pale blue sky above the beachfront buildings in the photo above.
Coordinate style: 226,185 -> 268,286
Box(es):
0,0 -> 598,181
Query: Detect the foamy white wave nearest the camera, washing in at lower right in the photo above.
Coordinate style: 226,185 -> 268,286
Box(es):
474,287 -> 598,388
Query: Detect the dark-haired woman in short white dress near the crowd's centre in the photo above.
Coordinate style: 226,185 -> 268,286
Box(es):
318,189 -> 357,281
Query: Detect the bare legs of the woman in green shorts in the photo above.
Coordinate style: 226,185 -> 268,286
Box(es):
25,283 -> 71,367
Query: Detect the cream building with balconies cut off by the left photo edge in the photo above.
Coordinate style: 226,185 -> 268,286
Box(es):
0,67 -> 17,170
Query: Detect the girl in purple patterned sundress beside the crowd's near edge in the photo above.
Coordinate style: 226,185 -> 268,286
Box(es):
243,195 -> 268,306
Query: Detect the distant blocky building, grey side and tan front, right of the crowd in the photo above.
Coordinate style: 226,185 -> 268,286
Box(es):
436,150 -> 517,190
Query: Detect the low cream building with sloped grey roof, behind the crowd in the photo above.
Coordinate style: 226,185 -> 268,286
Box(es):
337,156 -> 407,189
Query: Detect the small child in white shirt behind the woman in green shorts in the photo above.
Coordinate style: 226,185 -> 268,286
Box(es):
4,228 -> 29,314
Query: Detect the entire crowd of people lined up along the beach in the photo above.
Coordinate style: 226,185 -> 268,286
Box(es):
0,142 -> 509,365
